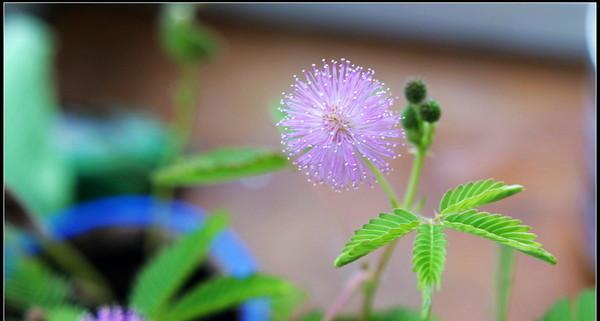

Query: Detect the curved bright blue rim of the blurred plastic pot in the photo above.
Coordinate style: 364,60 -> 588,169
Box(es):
6,196 -> 269,321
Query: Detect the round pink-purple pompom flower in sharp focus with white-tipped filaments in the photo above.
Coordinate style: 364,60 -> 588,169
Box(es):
277,58 -> 404,191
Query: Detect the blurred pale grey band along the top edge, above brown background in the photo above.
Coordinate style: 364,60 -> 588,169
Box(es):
205,3 -> 595,59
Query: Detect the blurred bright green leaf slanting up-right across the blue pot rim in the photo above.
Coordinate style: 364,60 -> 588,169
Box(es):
129,214 -> 227,319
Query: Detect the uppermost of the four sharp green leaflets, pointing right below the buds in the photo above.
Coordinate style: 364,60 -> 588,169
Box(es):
439,179 -> 523,214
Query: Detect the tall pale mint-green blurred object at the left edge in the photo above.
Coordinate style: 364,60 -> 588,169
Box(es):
4,14 -> 74,215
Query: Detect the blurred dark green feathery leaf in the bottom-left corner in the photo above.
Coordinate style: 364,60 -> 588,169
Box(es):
5,258 -> 70,309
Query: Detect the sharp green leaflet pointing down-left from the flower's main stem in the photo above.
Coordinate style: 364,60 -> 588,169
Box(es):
334,208 -> 419,267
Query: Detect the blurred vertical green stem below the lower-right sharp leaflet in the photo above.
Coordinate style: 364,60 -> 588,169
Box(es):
496,245 -> 515,321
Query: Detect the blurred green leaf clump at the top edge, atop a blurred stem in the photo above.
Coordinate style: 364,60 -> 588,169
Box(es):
160,3 -> 217,63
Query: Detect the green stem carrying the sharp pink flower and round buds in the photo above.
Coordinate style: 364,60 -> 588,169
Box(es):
361,142 -> 427,321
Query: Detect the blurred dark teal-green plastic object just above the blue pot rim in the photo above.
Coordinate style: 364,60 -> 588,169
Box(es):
55,108 -> 173,202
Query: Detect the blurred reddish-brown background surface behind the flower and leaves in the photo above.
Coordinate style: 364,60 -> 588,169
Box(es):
50,6 -> 595,321
